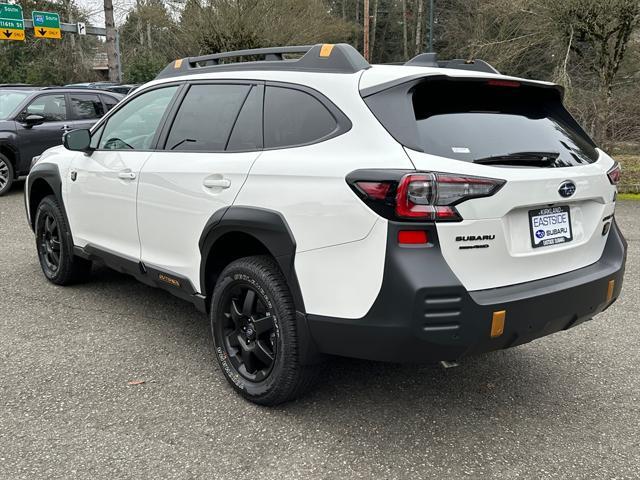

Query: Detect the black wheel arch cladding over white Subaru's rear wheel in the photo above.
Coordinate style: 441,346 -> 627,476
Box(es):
199,206 -> 305,314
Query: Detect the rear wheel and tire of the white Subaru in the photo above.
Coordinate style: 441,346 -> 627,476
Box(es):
210,256 -> 318,406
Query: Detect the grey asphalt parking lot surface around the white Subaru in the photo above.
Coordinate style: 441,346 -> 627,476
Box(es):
0,184 -> 640,480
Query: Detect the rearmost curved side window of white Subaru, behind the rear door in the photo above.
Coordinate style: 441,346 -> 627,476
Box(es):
264,87 -> 338,148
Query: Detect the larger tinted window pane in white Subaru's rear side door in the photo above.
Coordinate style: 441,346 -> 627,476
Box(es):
165,84 -> 251,152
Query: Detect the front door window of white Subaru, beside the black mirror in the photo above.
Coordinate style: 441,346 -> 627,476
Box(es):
94,86 -> 178,150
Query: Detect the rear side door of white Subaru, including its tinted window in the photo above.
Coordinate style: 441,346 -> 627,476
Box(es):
138,81 -> 264,290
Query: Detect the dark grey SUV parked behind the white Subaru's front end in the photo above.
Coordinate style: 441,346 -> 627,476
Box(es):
0,87 -> 123,196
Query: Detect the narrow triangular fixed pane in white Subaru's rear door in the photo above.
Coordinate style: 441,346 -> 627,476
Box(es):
227,87 -> 262,152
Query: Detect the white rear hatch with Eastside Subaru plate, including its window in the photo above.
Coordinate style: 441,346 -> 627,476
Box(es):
365,75 -> 616,290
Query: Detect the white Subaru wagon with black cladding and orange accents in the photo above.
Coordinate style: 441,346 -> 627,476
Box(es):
26,44 -> 626,405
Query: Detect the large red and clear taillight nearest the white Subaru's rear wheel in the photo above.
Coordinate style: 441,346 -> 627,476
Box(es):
347,170 -> 505,222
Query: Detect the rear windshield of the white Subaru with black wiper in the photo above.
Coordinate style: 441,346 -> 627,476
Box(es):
412,80 -> 598,167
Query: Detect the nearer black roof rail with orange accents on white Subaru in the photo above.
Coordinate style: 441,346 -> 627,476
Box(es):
156,43 -> 371,79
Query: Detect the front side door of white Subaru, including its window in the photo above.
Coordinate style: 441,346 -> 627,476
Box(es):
65,86 -> 179,262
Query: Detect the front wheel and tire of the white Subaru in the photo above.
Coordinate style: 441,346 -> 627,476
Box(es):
35,195 -> 91,285
